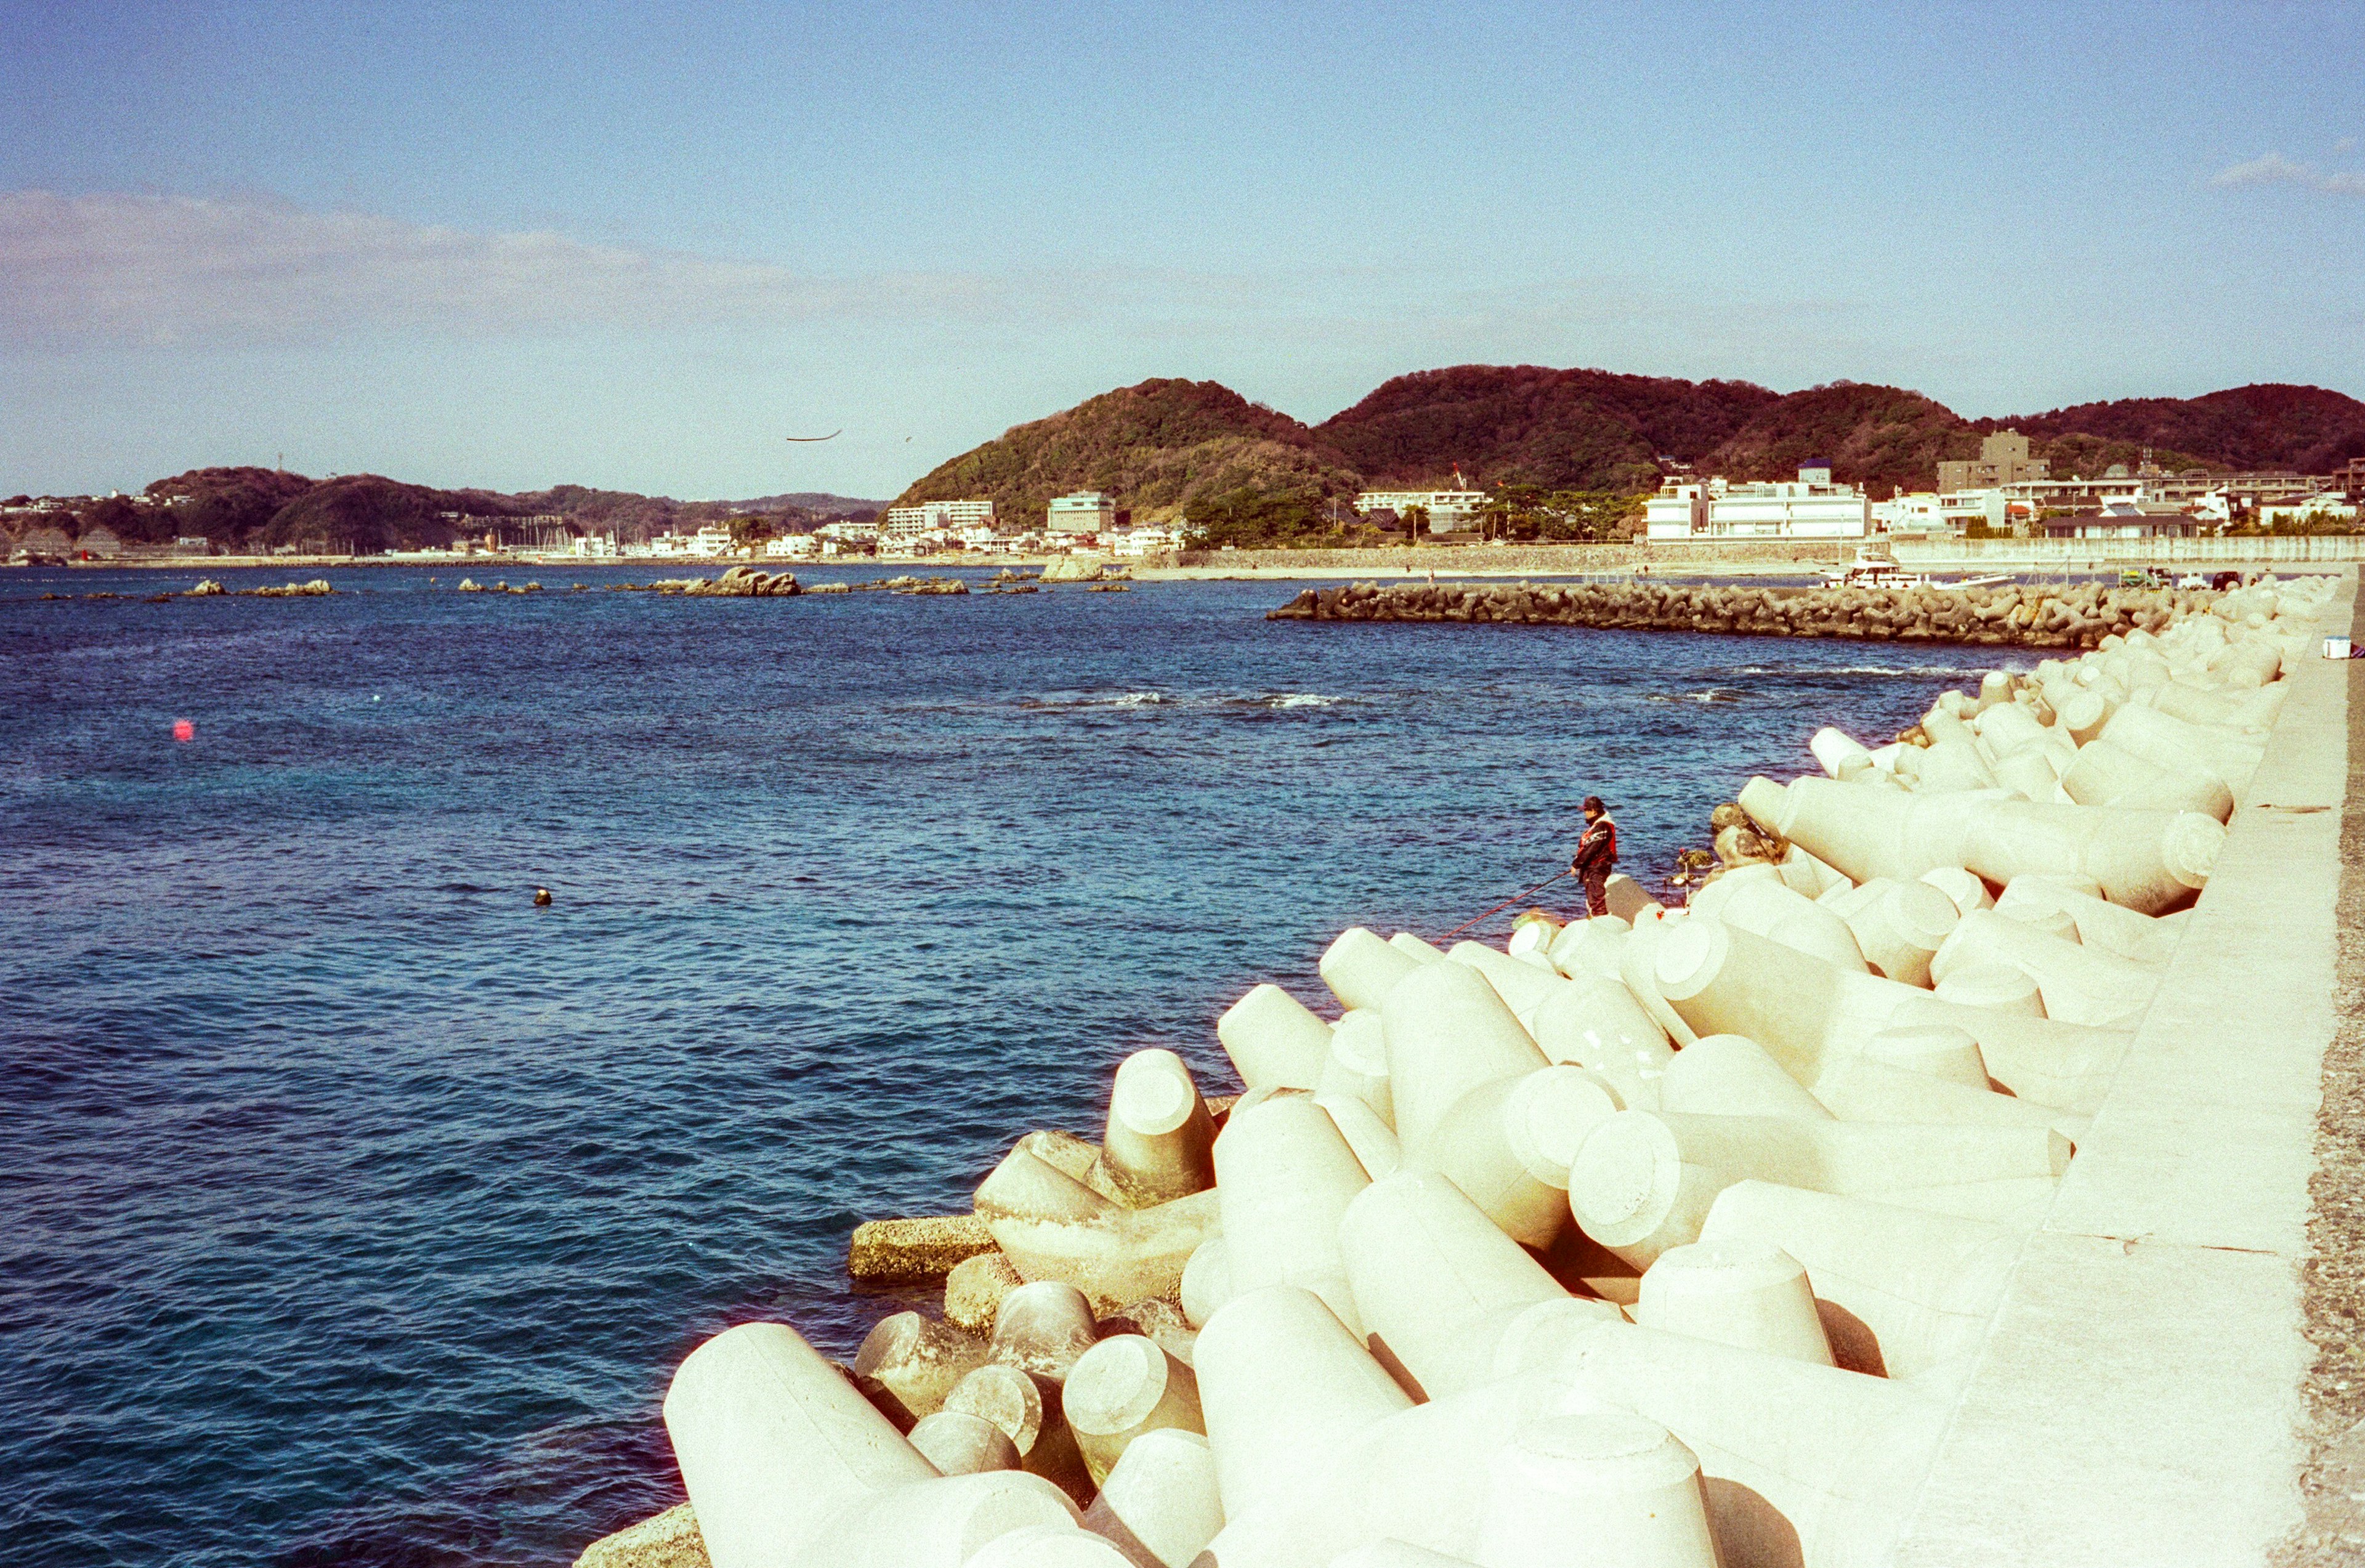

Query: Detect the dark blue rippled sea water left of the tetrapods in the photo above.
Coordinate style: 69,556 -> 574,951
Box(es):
0,570 -> 1977,1568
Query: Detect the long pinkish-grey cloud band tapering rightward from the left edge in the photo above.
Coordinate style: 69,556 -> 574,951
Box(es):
0,192 -> 984,346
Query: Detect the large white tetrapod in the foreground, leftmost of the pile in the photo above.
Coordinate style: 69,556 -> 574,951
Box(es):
665,1322 -> 1073,1568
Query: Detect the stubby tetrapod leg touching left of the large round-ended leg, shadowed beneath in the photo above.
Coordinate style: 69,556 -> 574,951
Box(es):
1402,1067 -> 1618,1251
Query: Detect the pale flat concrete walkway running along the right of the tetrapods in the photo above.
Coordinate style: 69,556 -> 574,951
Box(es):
1897,570 -> 2365,1568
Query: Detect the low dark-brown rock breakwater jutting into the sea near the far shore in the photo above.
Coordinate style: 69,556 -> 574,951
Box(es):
1265,582 -> 2213,648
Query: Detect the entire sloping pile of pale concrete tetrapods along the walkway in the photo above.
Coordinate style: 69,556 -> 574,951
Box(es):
586,580 -> 2332,1568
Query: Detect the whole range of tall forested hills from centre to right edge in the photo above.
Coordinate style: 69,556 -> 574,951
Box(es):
896,364 -> 2365,532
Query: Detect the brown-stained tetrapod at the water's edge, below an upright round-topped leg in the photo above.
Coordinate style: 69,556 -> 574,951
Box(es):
977,1149 -> 1220,1312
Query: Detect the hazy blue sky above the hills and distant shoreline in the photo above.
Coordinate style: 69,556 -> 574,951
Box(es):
0,0 -> 2365,499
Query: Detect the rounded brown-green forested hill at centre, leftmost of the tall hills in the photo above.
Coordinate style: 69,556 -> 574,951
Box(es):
896,381 -> 1357,530
